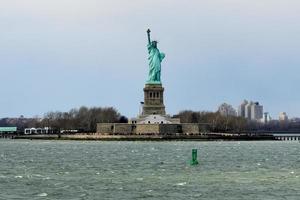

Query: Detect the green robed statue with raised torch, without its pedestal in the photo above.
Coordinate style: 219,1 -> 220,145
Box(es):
147,29 -> 165,84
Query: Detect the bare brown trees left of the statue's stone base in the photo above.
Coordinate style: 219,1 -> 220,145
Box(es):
0,106 -> 128,132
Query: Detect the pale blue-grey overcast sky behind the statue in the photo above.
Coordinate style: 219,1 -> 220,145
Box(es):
0,0 -> 300,118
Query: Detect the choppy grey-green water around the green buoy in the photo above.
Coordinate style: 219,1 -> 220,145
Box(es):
0,140 -> 300,200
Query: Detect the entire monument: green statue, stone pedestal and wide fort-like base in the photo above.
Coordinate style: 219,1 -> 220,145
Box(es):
97,29 -> 207,135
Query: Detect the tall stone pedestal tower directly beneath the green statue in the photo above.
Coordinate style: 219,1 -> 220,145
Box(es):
142,84 -> 166,116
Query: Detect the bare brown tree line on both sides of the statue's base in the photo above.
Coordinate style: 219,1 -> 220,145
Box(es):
0,106 -> 300,133
